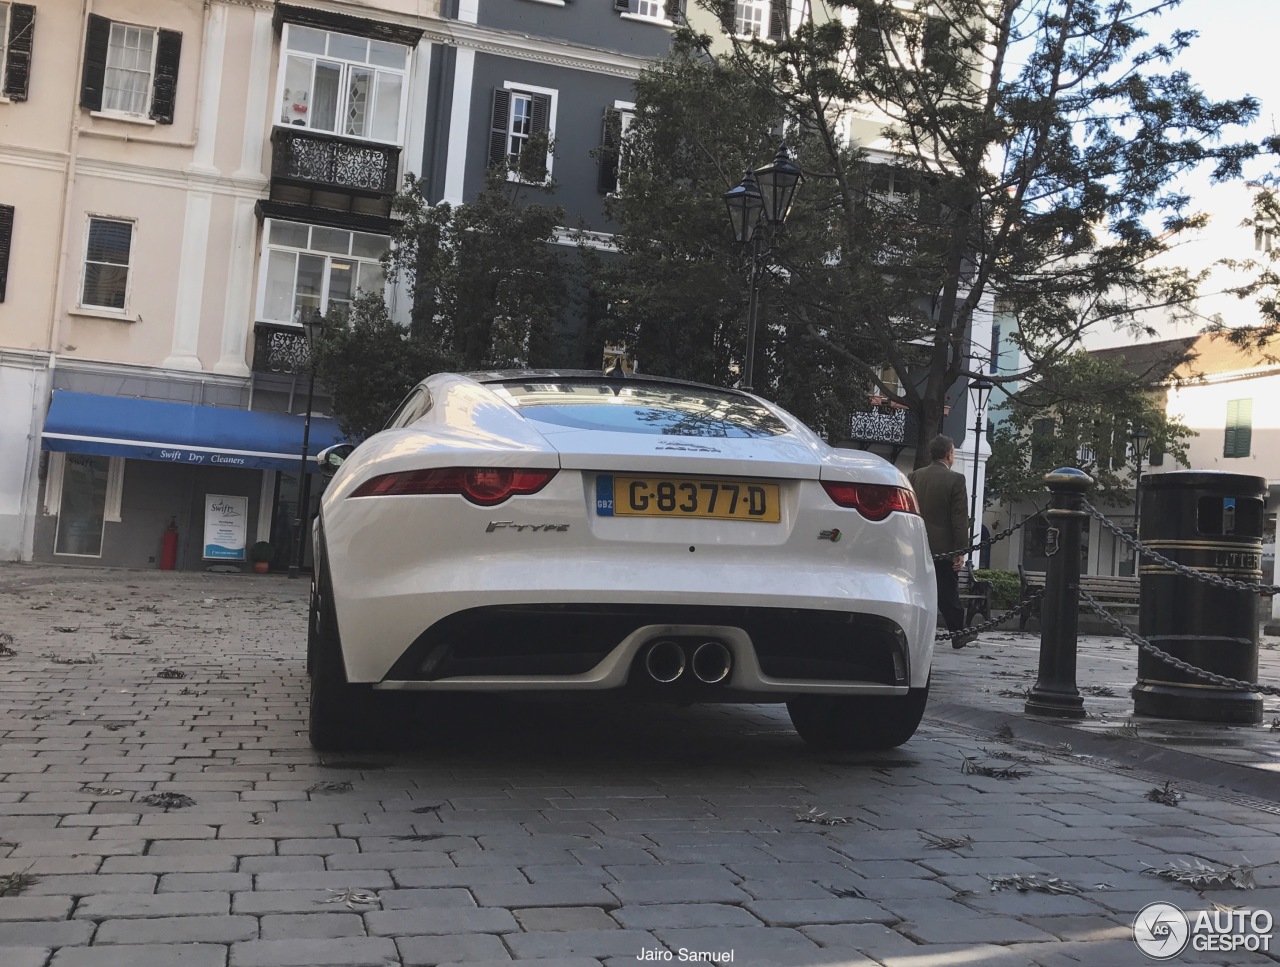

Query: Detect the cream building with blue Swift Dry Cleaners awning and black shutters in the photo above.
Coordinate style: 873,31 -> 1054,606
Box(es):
0,0 -> 438,567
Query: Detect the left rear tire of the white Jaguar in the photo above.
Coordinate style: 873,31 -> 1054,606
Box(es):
307,548 -> 372,752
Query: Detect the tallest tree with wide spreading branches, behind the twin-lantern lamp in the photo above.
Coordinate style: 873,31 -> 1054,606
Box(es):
606,0 -> 1258,459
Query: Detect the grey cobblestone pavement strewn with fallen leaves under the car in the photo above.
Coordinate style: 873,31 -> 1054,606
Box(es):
0,565 -> 1280,967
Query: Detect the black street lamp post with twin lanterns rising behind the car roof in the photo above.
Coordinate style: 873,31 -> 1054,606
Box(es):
722,141 -> 804,392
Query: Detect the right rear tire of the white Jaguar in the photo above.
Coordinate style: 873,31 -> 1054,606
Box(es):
787,684 -> 929,752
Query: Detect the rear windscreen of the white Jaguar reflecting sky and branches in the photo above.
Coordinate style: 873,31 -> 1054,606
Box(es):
490,379 -> 787,437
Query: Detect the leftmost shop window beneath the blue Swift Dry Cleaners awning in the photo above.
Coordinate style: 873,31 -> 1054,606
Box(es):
45,453 -> 124,557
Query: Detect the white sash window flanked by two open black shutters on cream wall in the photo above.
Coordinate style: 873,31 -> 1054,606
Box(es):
81,14 -> 182,124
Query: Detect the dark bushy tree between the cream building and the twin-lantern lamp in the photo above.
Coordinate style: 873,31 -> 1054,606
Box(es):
316,141 -> 567,438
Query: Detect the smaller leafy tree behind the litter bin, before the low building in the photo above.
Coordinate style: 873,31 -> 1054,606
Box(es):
986,352 -> 1194,506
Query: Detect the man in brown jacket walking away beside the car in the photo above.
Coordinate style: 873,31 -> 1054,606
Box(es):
908,433 -> 978,648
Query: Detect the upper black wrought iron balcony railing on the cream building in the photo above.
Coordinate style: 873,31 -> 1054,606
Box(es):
271,127 -> 401,197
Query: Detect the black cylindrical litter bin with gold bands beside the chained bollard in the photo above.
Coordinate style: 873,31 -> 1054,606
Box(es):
1133,470 -> 1267,722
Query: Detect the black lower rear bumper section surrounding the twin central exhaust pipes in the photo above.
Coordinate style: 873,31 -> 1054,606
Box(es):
376,605 -> 913,701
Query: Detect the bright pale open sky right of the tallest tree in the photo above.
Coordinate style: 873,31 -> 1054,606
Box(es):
1085,0 -> 1280,348
